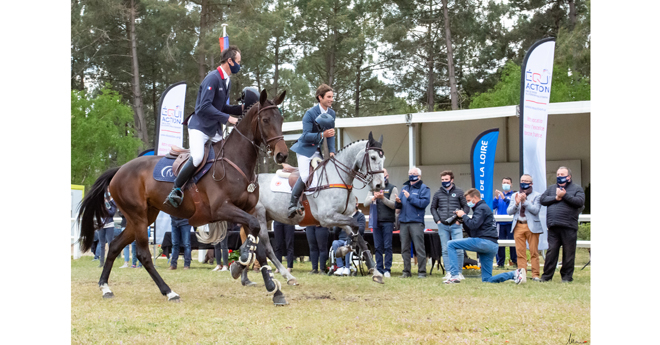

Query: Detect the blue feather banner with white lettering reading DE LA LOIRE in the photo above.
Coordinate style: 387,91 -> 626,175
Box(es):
470,128 -> 500,205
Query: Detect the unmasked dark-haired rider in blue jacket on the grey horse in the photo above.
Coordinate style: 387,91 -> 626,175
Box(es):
288,84 -> 336,218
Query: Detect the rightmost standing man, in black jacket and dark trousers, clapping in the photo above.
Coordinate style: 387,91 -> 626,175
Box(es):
541,166 -> 585,283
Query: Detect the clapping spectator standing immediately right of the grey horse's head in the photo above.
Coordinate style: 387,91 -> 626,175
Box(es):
364,169 -> 398,278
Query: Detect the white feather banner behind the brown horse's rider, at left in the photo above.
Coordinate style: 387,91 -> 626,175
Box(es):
155,81 -> 186,156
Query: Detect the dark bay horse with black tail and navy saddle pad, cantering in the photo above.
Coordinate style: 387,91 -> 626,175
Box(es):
78,90 -> 288,305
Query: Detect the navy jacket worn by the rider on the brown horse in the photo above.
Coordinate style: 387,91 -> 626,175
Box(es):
188,67 -> 242,137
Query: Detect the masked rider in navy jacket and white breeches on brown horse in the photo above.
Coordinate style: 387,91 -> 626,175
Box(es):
166,45 -> 243,207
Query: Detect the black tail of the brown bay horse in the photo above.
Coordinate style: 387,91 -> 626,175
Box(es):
78,167 -> 119,253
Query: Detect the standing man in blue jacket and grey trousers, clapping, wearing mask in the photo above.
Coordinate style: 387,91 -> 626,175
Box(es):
395,167 -> 431,278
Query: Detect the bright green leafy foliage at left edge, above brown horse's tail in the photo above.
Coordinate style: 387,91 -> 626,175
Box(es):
71,84 -> 140,188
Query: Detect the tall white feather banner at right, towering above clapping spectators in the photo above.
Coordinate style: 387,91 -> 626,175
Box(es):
520,37 -> 555,250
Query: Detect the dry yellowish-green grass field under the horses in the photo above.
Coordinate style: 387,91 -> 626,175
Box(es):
71,249 -> 591,344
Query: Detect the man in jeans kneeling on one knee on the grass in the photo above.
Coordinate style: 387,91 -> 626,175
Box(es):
445,188 -> 527,284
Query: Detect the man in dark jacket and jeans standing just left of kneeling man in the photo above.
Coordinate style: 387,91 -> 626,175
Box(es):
431,170 -> 470,280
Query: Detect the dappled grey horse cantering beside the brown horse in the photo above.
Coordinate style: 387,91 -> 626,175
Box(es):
241,133 -> 385,286
